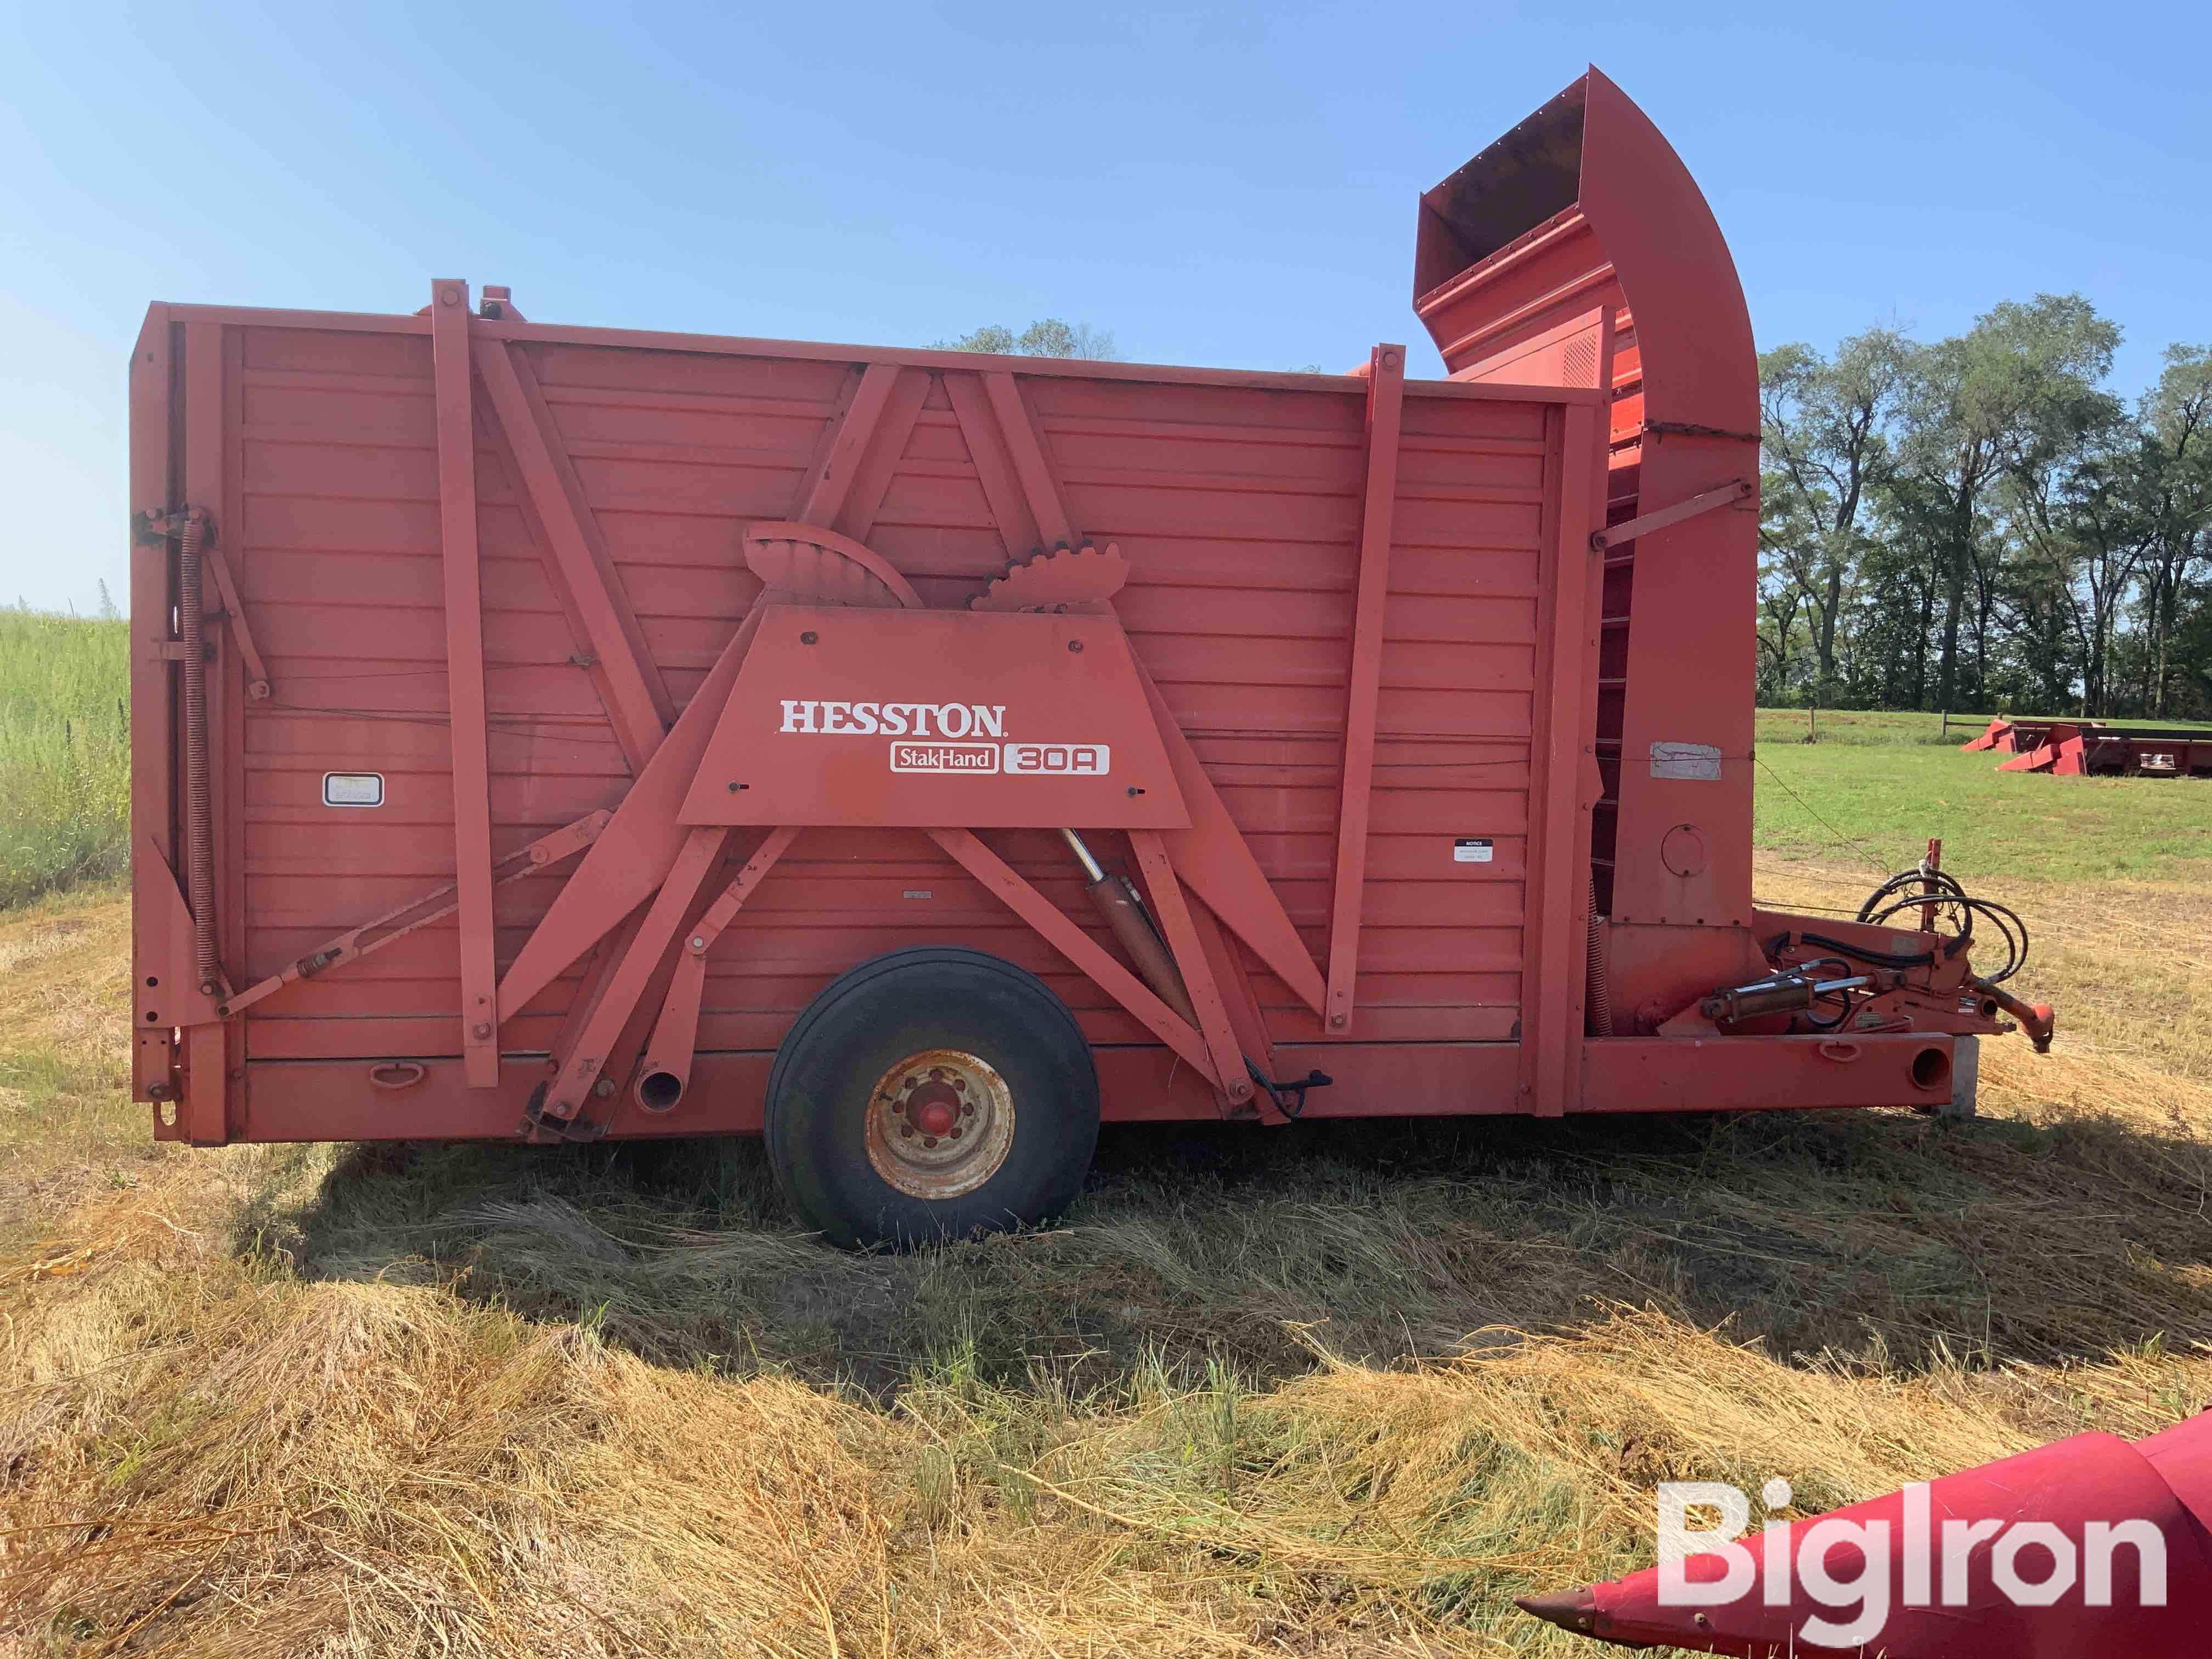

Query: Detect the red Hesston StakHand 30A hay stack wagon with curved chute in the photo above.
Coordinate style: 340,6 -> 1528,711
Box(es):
131,71 -> 2049,1241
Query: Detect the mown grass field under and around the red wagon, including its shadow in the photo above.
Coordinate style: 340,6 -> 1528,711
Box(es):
0,714 -> 2212,1659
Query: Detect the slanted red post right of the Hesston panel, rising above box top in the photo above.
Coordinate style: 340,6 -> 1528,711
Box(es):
1327,345 -> 1404,1037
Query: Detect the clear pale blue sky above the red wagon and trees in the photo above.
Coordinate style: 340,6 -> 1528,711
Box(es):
0,0 -> 2212,613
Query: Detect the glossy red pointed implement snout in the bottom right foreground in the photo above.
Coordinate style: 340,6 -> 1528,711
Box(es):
1522,1413 -> 2212,1659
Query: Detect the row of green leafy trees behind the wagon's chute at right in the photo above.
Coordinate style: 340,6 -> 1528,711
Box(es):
1758,294 -> 2212,719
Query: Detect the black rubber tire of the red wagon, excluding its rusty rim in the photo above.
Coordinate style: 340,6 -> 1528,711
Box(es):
763,945 -> 1099,1250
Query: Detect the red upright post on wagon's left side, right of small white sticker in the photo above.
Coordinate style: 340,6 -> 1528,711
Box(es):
429,279 -> 500,1088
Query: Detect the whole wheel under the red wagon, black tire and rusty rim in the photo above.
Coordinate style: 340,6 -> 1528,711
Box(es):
763,945 -> 1099,1248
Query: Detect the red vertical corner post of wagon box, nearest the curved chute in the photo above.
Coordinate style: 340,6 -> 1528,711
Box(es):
1520,403 -> 1604,1117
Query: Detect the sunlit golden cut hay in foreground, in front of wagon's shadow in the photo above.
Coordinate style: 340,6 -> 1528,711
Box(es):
0,1194 -> 2212,1657
